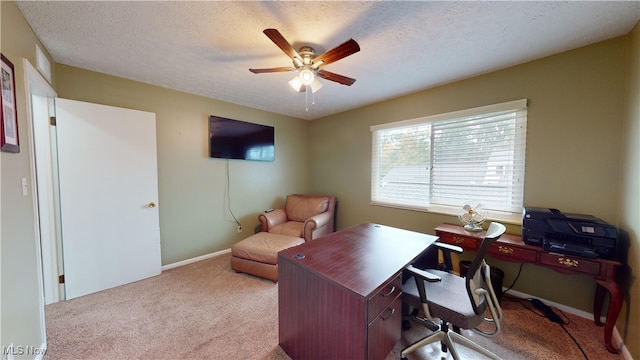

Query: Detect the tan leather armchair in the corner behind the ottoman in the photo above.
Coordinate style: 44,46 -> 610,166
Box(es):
258,194 -> 336,241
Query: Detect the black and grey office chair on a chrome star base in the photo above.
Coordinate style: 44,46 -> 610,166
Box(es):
400,222 -> 506,360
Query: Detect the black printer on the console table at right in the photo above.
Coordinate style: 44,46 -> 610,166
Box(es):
522,207 -> 618,260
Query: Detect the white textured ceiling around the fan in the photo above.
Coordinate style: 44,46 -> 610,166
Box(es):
17,1 -> 640,119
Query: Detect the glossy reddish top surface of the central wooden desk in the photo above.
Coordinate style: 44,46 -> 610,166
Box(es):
279,223 -> 438,297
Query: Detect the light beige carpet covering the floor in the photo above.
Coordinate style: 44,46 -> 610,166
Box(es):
45,254 -> 622,360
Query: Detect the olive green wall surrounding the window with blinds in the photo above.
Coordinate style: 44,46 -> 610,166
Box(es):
309,37 -> 629,324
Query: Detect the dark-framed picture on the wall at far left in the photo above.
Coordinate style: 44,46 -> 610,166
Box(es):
0,54 -> 20,153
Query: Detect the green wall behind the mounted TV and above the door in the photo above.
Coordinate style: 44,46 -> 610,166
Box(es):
55,64 -> 310,265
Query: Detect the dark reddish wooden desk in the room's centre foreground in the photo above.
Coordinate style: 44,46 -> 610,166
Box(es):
278,224 -> 437,359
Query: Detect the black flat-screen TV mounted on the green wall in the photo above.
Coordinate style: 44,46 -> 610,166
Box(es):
209,115 -> 275,161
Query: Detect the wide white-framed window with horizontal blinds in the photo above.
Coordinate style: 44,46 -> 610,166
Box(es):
371,99 -> 527,222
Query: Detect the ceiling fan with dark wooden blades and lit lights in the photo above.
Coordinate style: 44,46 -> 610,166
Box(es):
249,29 -> 360,93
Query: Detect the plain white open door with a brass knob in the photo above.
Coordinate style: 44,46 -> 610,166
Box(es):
56,98 -> 161,299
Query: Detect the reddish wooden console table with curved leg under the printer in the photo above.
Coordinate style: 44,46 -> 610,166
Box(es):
435,224 -> 623,354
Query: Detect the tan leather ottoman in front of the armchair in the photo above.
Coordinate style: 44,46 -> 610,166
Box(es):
231,232 -> 304,282
